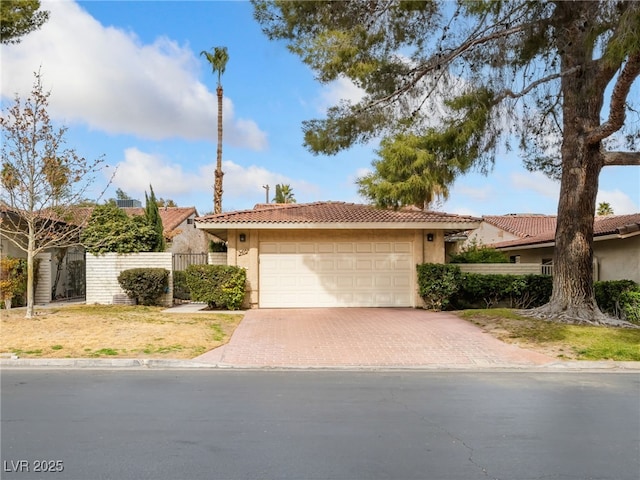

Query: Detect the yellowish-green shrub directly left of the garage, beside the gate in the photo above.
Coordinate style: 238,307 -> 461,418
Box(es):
186,265 -> 247,310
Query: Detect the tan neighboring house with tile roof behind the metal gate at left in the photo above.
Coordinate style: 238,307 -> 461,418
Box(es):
123,207 -> 210,253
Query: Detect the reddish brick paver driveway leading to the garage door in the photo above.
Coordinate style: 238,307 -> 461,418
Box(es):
194,308 -> 555,368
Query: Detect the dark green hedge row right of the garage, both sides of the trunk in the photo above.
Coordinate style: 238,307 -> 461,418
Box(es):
417,263 -> 640,322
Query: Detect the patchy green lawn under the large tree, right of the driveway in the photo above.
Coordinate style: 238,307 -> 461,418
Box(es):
458,308 -> 640,361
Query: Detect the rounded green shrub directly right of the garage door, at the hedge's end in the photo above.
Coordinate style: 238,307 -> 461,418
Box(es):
416,263 -> 462,310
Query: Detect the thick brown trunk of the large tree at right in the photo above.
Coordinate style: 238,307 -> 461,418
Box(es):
535,2 -> 617,324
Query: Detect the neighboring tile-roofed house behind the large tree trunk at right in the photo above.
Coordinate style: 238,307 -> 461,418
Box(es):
467,213 -> 640,283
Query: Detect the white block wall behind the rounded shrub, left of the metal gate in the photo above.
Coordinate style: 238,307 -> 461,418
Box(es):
86,252 -> 173,307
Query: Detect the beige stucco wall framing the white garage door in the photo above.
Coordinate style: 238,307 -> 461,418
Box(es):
221,229 -> 445,308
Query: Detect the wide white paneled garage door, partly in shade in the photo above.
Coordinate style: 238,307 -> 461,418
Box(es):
259,242 -> 415,308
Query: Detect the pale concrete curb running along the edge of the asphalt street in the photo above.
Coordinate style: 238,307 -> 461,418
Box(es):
0,358 -> 640,373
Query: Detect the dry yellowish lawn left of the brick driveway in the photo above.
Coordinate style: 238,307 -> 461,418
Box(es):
0,305 -> 242,359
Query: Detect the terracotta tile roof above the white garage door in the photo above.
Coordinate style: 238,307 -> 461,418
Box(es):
198,202 -> 480,228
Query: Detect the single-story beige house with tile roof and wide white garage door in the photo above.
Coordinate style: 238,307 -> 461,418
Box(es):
196,202 -> 480,308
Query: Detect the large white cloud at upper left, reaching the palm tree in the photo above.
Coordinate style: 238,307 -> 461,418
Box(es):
1,1 -> 267,150
